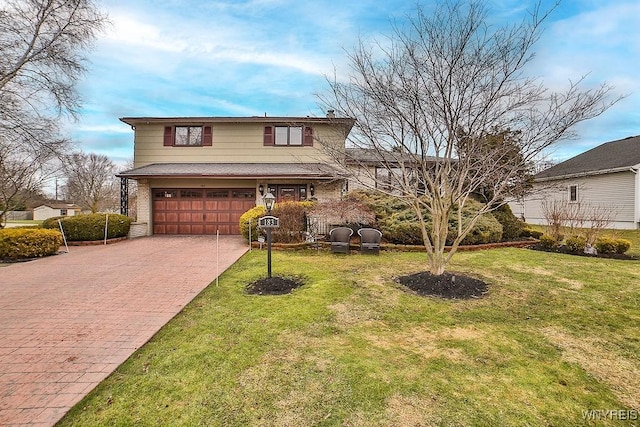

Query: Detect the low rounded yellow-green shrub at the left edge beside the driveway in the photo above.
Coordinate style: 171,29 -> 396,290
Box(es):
0,228 -> 62,259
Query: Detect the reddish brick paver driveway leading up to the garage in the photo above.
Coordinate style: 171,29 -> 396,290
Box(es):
0,236 -> 247,426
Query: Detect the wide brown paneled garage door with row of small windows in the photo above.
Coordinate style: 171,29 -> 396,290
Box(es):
153,188 -> 256,234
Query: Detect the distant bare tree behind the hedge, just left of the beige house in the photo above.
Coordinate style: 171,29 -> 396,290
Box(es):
63,153 -> 119,213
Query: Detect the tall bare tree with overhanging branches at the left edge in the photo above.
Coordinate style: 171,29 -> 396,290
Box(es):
0,0 -> 106,226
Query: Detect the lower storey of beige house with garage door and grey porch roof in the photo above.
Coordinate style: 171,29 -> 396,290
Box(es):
117,163 -> 342,236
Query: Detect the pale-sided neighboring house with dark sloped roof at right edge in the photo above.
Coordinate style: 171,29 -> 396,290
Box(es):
510,136 -> 640,229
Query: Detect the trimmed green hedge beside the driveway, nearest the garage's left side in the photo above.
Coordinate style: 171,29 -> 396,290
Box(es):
42,213 -> 131,242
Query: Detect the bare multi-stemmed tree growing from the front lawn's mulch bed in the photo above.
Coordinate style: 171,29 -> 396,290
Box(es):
321,0 -> 617,274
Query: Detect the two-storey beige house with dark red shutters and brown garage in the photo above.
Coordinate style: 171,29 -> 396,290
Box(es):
117,111 -> 354,235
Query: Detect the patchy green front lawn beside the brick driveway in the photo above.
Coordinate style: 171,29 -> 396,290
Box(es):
60,249 -> 640,426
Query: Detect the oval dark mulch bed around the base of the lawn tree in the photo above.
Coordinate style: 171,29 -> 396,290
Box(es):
396,271 -> 489,299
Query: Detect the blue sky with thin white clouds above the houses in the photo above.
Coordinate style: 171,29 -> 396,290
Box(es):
66,0 -> 640,164
